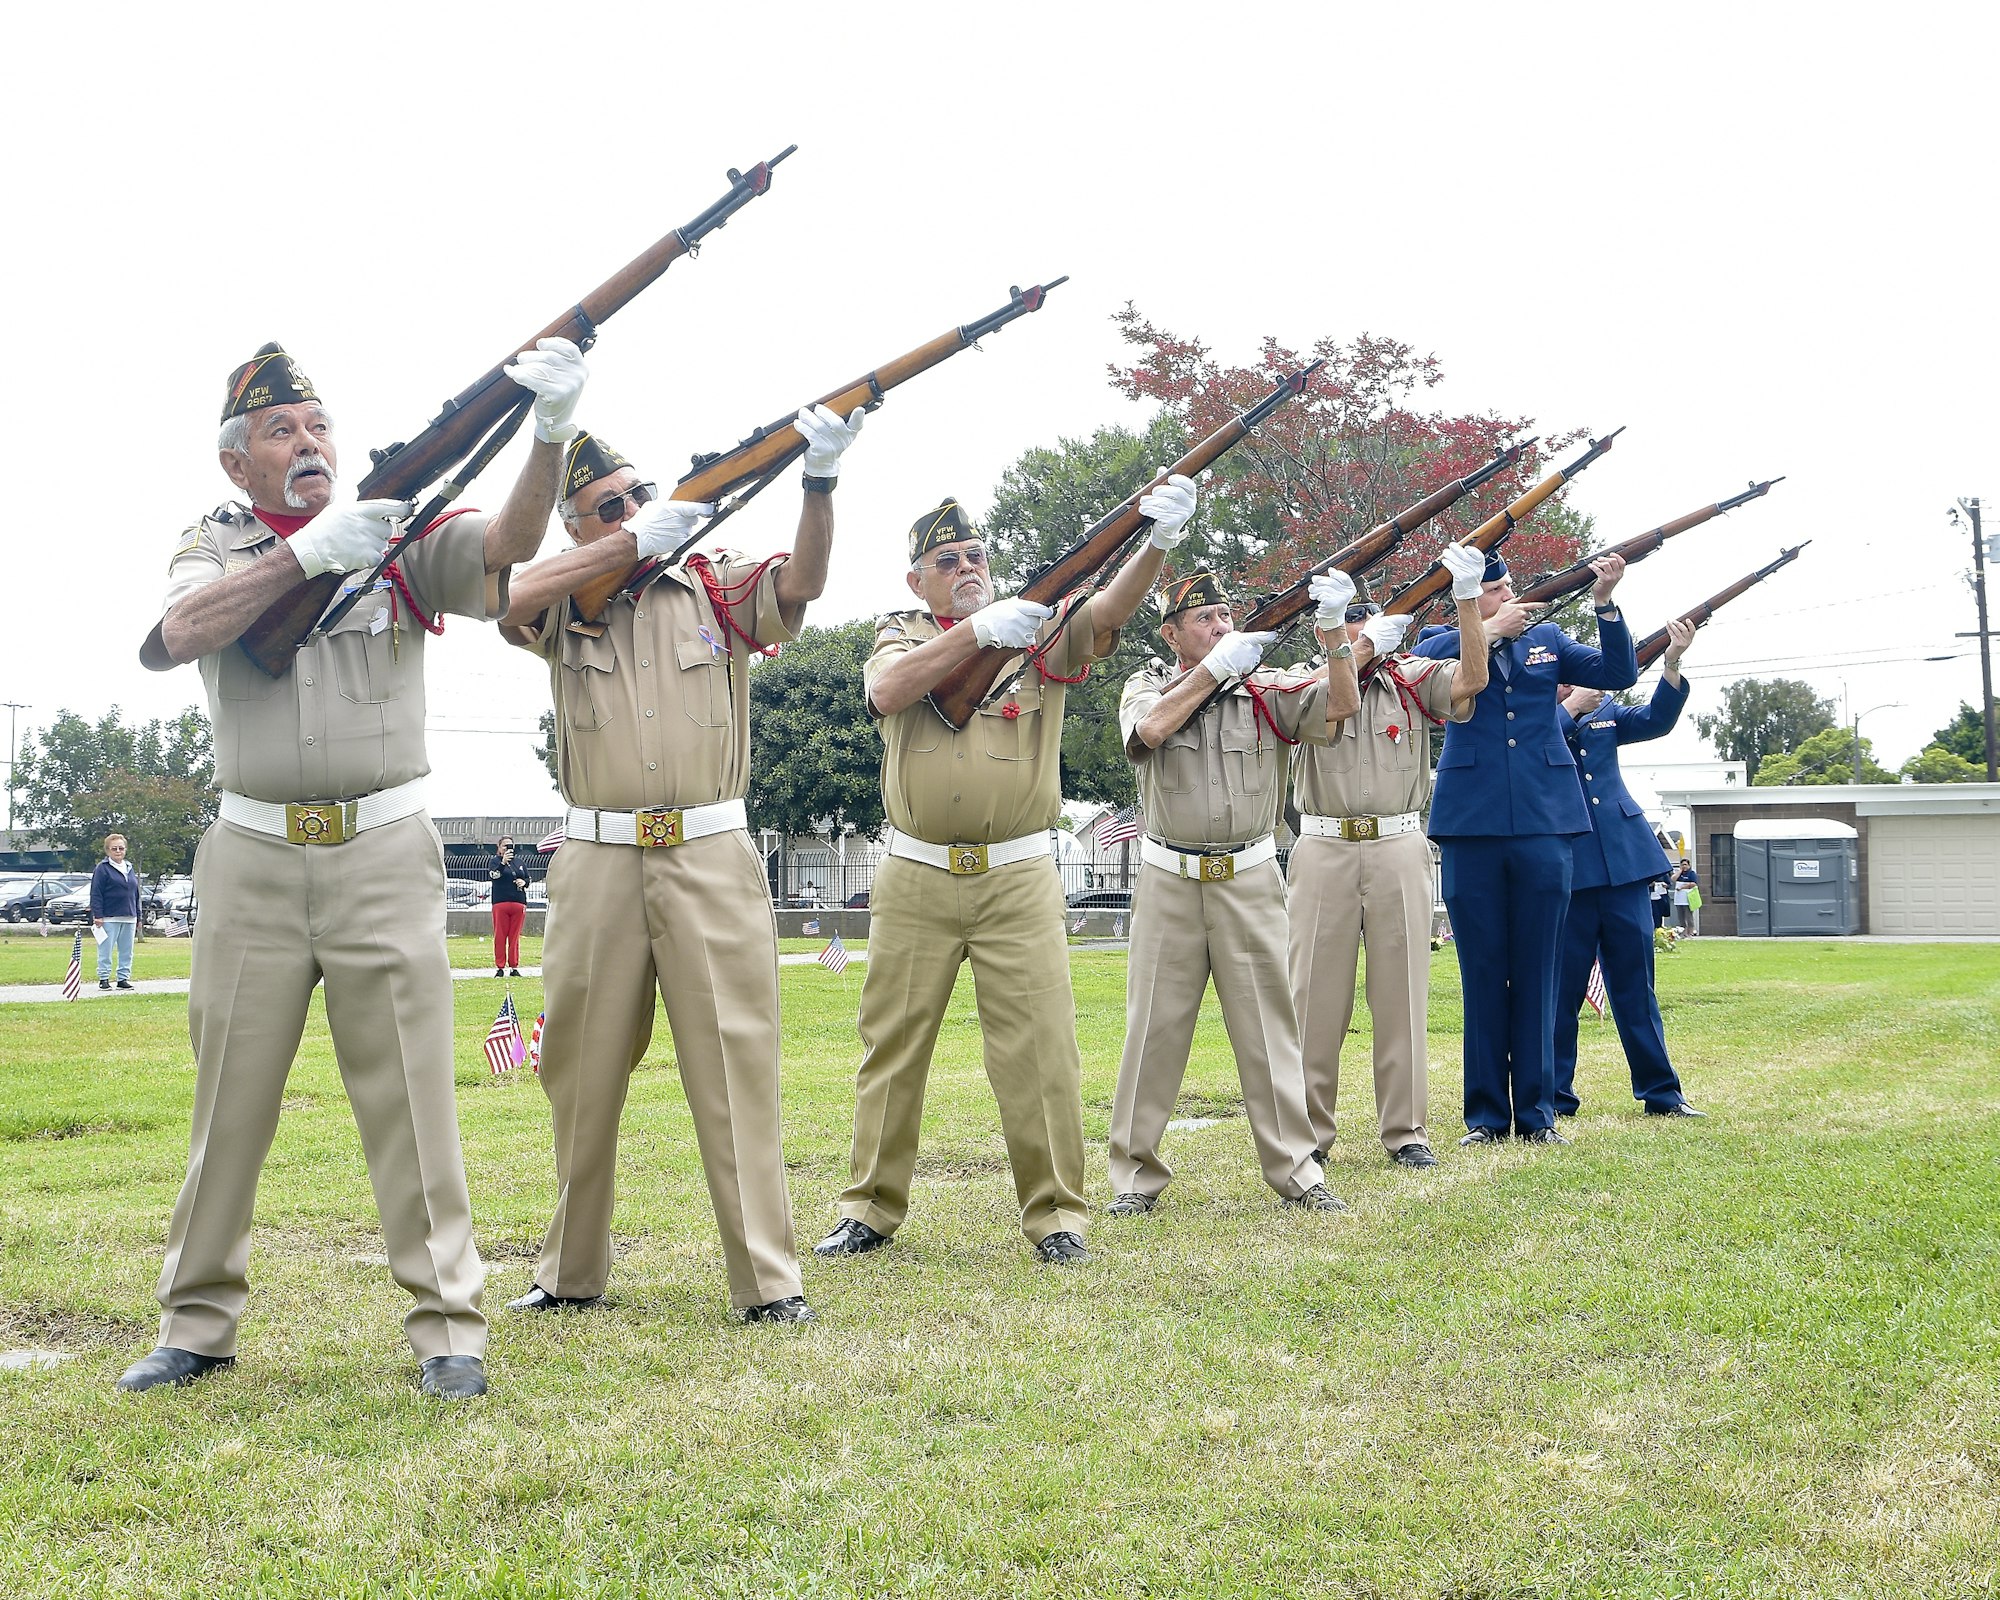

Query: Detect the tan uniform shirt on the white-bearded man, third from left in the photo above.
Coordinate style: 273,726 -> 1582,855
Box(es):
862,600 -> 1096,844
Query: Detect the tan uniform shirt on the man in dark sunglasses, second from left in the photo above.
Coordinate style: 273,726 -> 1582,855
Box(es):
534,552 -> 792,810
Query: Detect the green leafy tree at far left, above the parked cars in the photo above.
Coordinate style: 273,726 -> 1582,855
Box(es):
14,706 -> 216,872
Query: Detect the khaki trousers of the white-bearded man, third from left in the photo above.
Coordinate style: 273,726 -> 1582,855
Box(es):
840,856 -> 1086,1244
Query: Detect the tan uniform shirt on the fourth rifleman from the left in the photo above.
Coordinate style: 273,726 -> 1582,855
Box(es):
1118,660 -> 1326,846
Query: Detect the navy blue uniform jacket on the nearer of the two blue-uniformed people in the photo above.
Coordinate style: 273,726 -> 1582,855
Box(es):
1412,618 -> 1638,838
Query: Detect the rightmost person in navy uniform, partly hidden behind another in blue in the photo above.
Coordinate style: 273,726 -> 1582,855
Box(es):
1556,620 -> 1702,1116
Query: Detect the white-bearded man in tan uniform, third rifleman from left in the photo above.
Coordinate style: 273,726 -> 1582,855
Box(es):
814,478 -> 1194,1262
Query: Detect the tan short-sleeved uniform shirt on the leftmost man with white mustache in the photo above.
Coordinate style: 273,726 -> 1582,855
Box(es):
162,506 -> 506,804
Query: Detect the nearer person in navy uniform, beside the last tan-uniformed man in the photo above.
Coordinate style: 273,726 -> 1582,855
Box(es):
1414,554 -> 1638,1144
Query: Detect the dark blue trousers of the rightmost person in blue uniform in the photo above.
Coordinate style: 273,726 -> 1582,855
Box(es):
1556,882 -> 1684,1116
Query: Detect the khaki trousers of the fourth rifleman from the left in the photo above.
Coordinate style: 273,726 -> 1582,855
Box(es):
1110,862 -> 1322,1198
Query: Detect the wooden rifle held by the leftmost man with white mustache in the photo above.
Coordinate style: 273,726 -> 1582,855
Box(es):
240,144 -> 798,678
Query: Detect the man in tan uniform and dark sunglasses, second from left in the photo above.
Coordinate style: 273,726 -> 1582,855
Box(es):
502,406 -> 864,1322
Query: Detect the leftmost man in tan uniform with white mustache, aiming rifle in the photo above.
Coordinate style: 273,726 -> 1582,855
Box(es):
118,340 -> 584,1398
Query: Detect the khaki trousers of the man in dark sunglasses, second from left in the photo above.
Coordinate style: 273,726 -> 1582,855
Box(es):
534,830 -> 800,1310
